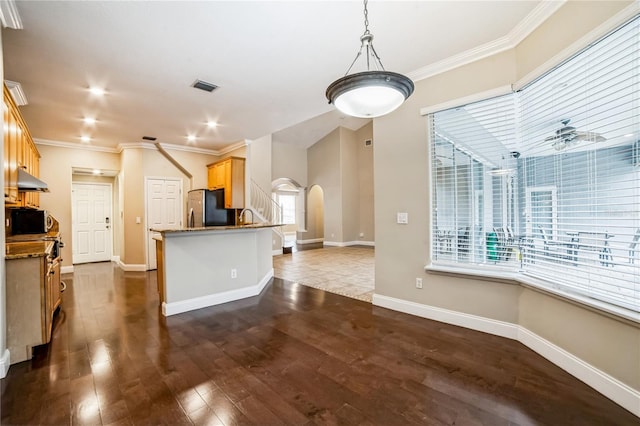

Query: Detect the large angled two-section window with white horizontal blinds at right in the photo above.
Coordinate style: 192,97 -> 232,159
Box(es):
431,18 -> 640,311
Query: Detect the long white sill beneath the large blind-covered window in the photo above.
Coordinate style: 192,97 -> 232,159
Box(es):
424,264 -> 640,327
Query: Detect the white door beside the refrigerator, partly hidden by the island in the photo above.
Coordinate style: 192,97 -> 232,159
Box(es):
146,178 -> 183,269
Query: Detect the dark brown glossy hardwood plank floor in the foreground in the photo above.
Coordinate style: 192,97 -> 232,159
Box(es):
0,263 -> 640,425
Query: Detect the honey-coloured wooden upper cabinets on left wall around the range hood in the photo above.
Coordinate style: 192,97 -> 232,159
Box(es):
2,85 -> 40,207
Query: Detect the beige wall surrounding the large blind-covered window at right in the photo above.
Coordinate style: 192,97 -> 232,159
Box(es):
373,2 -> 640,390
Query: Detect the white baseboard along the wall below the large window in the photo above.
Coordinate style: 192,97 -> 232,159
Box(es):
372,294 -> 640,417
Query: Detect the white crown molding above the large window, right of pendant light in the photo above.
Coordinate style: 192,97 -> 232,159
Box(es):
407,0 -> 566,81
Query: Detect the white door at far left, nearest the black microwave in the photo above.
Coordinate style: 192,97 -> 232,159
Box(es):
71,183 -> 113,263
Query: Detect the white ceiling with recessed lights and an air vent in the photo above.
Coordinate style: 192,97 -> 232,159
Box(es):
2,1 -> 542,150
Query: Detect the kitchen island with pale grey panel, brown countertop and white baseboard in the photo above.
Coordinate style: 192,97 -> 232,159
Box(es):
152,224 -> 278,316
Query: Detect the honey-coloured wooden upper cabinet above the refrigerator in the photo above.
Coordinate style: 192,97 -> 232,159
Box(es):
207,157 -> 245,209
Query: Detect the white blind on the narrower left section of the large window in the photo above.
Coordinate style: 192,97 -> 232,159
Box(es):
431,95 -> 517,264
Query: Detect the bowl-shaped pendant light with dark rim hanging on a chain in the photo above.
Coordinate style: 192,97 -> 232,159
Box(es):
326,0 -> 414,118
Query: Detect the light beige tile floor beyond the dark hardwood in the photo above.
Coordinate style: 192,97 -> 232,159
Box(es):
273,246 -> 374,303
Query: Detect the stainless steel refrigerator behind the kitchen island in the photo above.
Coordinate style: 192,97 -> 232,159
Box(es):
187,189 -> 235,228
